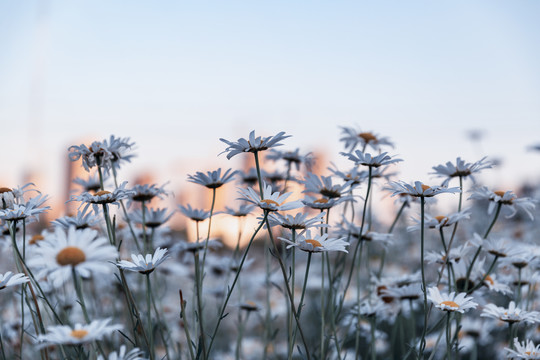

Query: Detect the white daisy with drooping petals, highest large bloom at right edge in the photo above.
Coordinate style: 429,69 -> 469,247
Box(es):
469,186 -> 536,220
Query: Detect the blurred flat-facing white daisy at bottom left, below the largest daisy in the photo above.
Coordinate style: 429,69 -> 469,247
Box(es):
37,318 -> 122,346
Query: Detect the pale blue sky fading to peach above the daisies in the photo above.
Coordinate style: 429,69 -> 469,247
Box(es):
0,0 -> 540,207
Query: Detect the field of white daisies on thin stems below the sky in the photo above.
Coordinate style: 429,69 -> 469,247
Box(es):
0,127 -> 540,360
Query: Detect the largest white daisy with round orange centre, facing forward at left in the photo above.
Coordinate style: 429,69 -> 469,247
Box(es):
28,227 -> 117,287
